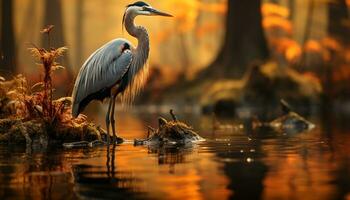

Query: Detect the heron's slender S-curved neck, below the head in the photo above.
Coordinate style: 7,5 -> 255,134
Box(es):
125,12 -> 149,64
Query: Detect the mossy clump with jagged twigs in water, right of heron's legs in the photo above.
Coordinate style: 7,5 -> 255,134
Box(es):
134,110 -> 204,145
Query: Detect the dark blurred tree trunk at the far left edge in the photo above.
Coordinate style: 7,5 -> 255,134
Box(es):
0,0 -> 16,77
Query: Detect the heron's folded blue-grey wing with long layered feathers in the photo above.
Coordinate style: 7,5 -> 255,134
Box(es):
72,39 -> 132,116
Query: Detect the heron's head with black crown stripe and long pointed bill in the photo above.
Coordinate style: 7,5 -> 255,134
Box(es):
123,1 -> 173,23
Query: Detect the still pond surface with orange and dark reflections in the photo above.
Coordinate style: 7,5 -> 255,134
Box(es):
0,108 -> 350,200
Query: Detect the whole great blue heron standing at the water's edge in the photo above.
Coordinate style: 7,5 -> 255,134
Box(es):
72,1 -> 171,144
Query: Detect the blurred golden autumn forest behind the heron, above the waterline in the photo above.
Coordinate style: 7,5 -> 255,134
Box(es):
0,0 -> 350,118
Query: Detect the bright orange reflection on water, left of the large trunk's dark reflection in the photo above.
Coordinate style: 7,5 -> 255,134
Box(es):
77,140 -> 230,199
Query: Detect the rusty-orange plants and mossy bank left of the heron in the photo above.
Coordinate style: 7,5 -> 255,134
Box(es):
0,25 -> 106,145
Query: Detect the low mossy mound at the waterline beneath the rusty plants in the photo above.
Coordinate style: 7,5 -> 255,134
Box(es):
0,118 -> 106,145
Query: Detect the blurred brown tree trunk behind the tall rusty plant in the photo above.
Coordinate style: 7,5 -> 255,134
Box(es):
42,0 -> 73,80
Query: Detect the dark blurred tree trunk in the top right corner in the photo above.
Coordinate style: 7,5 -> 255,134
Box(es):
328,0 -> 350,44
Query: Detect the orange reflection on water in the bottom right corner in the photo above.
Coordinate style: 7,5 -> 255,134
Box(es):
263,129 -> 350,199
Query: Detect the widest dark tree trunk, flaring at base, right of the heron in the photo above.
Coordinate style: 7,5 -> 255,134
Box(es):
202,0 -> 268,78
